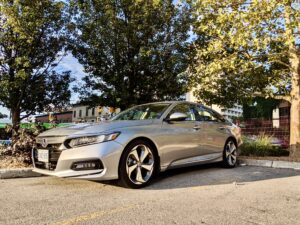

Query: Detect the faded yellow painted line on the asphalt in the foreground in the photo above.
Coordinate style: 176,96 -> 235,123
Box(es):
52,205 -> 135,225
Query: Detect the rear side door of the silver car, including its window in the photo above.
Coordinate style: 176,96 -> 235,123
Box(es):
195,105 -> 228,154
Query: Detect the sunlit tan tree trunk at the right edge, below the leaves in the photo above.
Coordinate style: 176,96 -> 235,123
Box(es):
290,49 -> 300,157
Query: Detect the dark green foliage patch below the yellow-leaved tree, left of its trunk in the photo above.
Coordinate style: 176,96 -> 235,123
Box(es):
243,97 -> 280,119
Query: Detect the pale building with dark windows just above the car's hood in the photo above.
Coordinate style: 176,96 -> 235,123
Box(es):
72,105 -> 120,123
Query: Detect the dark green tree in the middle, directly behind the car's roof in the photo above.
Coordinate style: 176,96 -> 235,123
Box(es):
72,0 -> 190,109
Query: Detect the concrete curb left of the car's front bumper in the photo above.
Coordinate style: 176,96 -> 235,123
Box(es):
0,168 -> 42,179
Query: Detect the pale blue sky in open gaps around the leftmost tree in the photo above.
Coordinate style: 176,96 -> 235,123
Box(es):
0,54 -> 85,123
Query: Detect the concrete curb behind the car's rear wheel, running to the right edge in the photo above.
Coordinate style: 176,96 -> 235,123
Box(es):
238,159 -> 300,170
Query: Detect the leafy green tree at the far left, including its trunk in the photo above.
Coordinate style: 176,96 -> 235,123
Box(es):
0,0 -> 71,136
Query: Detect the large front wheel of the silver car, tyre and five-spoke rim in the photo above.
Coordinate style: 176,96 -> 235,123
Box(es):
119,140 -> 158,189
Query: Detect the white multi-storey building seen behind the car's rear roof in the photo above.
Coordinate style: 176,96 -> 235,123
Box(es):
185,91 -> 243,120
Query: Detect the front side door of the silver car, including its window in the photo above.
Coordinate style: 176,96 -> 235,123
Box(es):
161,103 -> 205,163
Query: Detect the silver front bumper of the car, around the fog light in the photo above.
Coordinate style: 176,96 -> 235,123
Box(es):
33,141 -> 124,180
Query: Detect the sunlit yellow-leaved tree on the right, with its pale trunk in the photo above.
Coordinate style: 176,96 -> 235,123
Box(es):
190,0 -> 300,156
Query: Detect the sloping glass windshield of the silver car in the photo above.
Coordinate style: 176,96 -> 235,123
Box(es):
112,103 -> 170,120
